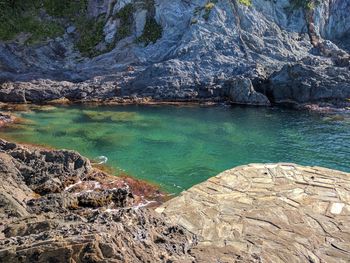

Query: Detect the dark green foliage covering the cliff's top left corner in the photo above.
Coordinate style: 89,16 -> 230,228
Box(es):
0,0 -> 106,56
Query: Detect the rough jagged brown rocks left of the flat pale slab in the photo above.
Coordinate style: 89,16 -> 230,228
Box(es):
0,140 -> 196,263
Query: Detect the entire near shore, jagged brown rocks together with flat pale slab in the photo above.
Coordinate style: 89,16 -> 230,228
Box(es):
0,140 -> 350,263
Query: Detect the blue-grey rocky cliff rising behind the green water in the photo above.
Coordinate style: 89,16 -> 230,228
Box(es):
0,0 -> 350,105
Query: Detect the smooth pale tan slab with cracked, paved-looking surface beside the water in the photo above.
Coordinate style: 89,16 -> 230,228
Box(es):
156,163 -> 350,263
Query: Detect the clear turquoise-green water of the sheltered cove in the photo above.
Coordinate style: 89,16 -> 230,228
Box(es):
2,106 -> 350,193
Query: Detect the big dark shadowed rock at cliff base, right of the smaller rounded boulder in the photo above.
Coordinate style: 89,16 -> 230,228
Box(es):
265,58 -> 350,104
